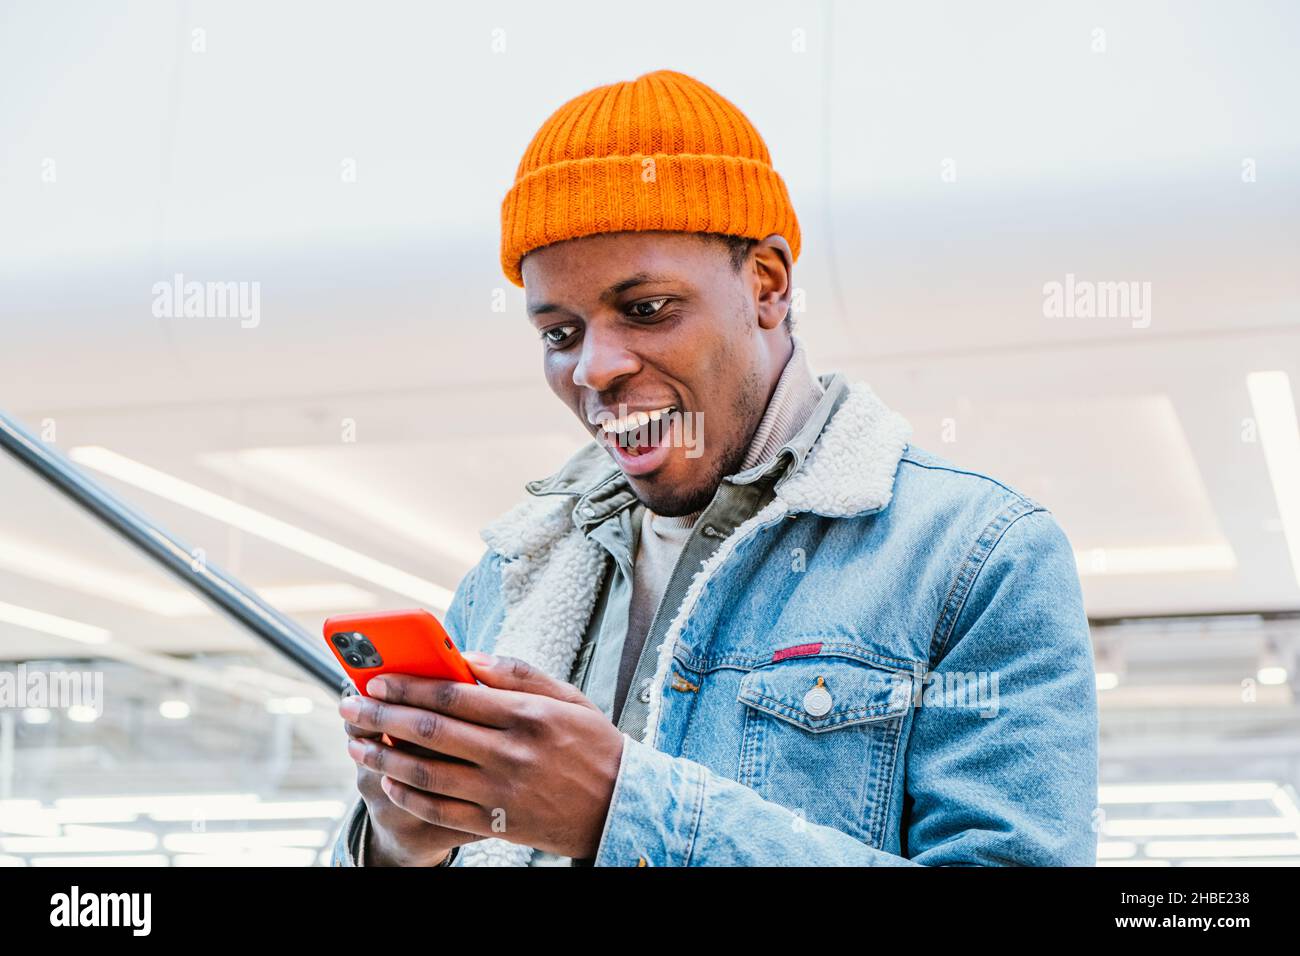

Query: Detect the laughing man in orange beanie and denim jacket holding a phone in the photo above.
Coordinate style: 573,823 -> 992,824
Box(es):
334,70 -> 1097,866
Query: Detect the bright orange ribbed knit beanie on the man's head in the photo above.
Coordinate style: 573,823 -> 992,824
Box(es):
501,70 -> 800,286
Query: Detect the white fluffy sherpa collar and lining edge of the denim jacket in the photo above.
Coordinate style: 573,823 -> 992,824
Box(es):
460,375 -> 911,866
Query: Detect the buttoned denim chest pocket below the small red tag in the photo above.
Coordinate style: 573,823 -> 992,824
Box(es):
737,656 -> 913,845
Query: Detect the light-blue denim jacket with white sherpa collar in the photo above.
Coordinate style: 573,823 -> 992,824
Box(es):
334,376 -> 1097,866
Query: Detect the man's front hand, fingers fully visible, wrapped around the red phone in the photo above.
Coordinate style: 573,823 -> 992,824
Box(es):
339,652 -> 623,858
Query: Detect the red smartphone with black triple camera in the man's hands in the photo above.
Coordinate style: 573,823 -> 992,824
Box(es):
322,607 -> 478,697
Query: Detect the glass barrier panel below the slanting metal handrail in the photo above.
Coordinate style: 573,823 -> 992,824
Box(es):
0,426 -> 355,866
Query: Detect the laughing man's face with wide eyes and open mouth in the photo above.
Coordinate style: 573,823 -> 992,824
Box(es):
523,232 -> 784,515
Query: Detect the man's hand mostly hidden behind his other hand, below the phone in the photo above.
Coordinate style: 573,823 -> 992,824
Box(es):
341,695 -> 482,866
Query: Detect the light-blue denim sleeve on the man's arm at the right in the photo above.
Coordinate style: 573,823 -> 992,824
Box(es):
595,510 -> 1097,866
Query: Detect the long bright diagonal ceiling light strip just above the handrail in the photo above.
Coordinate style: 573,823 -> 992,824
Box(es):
69,446 -> 452,610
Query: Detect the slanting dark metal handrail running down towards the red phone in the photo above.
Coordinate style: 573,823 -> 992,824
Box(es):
0,411 -> 347,693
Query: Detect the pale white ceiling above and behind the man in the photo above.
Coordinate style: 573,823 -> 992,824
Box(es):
0,3 -> 1300,657
